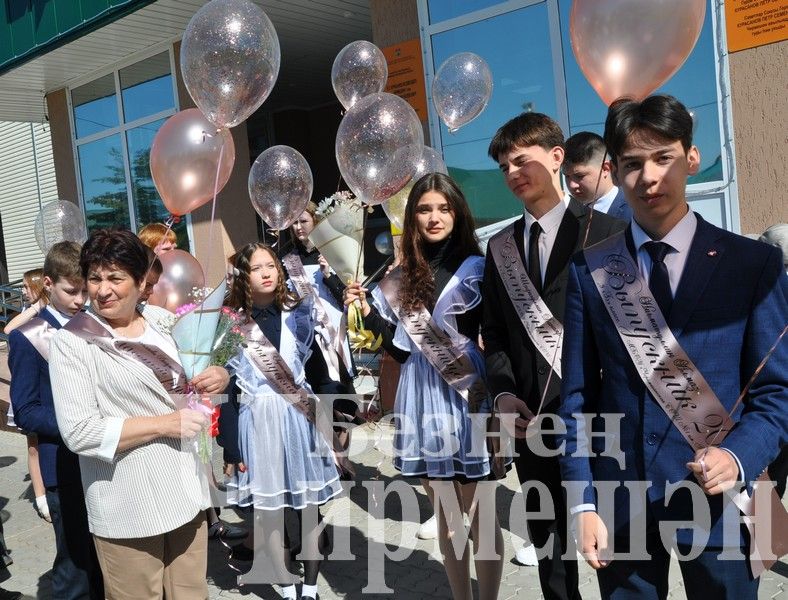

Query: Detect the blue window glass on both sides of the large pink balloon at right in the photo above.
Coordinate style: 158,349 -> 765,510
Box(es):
559,0 -> 723,184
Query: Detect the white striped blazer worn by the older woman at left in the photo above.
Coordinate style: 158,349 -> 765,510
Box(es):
49,306 -> 210,539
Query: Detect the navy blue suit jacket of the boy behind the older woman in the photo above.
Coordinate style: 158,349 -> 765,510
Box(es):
8,310 -> 81,487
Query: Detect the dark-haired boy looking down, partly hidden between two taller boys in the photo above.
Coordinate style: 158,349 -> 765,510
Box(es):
561,131 -> 632,221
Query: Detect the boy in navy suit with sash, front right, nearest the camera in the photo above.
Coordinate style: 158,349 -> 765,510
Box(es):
560,96 -> 788,600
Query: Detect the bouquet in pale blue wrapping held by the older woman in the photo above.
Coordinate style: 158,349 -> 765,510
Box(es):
170,281 -> 243,463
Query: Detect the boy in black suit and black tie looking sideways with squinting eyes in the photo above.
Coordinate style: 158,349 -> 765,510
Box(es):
482,113 -> 625,599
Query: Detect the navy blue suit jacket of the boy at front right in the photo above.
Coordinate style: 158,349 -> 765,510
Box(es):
560,217 -> 788,547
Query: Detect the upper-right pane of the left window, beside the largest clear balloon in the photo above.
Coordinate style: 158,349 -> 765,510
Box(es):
119,52 -> 175,123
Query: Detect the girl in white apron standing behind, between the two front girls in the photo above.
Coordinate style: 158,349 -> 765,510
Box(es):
282,202 -> 363,448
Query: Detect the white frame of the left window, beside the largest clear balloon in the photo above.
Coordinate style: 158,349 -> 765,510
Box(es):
66,41 -> 195,248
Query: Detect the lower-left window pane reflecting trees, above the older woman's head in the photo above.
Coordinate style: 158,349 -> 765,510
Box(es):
79,133 -> 131,230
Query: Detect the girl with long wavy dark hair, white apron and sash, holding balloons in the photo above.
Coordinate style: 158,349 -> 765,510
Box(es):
345,173 -> 503,599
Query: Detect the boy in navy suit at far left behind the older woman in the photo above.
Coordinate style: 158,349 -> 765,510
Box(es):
8,242 -> 104,600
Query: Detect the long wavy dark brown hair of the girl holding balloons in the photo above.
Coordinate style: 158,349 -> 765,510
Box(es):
400,173 -> 482,310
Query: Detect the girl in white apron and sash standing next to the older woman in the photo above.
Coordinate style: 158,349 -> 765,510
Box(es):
219,243 -> 350,599
